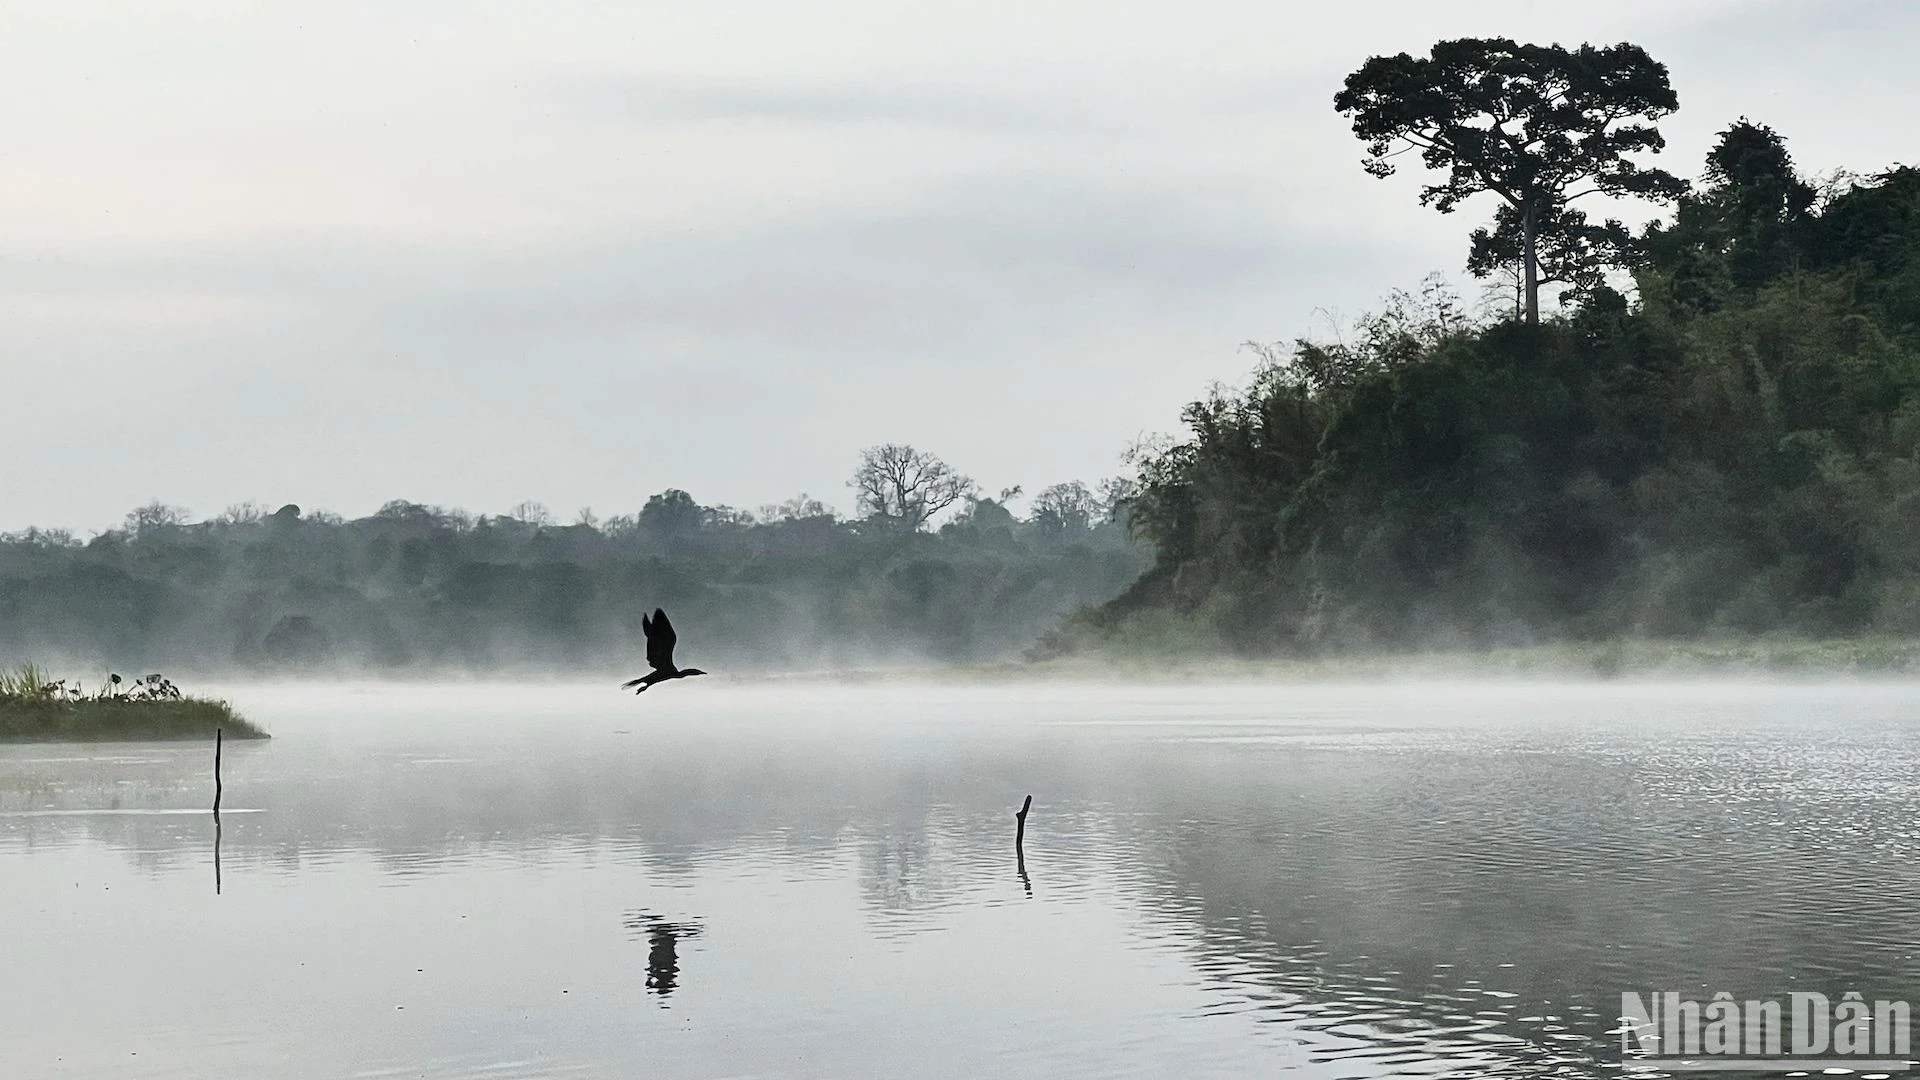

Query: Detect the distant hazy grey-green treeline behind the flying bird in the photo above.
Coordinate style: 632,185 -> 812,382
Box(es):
0,466 -> 1148,675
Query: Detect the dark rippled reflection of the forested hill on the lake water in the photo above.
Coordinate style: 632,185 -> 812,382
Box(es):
1121,744 -> 1920,1076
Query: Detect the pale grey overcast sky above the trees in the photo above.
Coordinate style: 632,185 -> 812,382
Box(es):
0,0 -> 1920,532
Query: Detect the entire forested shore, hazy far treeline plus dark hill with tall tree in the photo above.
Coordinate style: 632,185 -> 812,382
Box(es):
15,38 -> 1920,669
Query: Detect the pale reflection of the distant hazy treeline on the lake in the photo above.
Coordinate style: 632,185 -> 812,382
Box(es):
0,738 -> 1052,930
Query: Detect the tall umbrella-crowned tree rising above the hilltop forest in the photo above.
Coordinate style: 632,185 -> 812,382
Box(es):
1332,38 -> 1686,323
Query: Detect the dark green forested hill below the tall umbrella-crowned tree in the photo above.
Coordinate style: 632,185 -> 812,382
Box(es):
1052,100 -> 1920,653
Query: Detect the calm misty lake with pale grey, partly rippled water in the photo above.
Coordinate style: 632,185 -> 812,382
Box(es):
0,680 -> 1920,1080
